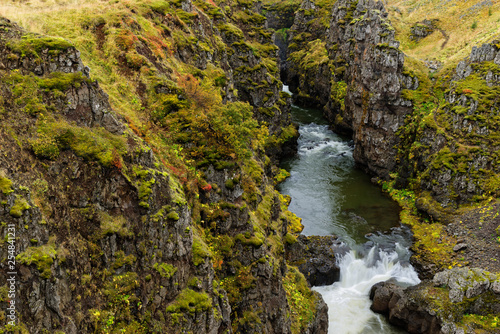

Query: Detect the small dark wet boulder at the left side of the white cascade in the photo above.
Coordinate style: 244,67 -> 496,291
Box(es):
286,235 -> 340,286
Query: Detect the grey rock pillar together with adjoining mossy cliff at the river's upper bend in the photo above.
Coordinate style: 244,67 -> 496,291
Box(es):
287,1 -> 418,178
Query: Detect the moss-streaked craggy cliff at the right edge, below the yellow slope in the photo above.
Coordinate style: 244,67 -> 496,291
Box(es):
410,43 -> 500,209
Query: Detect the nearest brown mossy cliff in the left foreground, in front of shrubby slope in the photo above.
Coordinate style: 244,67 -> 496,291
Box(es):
0,20 -> 231,333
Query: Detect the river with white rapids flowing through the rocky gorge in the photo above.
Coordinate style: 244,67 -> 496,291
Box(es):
280,86 -> 419,334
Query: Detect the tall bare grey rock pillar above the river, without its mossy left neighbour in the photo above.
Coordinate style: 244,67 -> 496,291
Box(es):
326,0 -> 418,178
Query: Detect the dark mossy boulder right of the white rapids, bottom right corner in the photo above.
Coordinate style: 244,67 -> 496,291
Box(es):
370,268 -> 500,334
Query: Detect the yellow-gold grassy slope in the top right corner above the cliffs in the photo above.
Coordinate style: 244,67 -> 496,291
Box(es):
385,0 -> 500,67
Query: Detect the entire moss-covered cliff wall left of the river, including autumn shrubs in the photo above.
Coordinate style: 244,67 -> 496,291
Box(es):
0,1 -> 320,333
